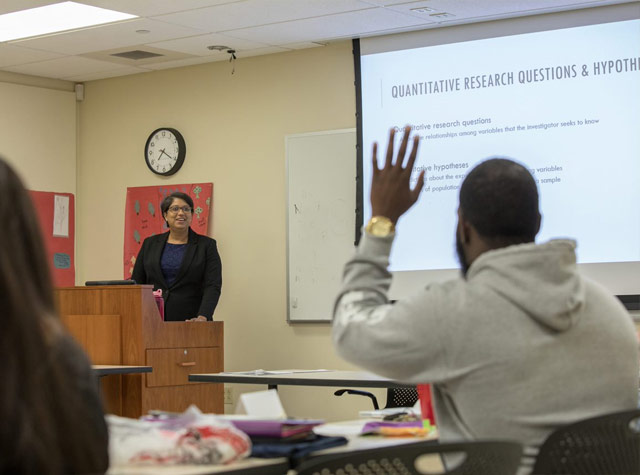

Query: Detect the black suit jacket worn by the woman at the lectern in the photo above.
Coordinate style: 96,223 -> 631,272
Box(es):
131,229 -> 222,321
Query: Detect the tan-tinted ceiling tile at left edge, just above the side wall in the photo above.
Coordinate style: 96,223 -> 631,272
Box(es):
3,56 -> 134,79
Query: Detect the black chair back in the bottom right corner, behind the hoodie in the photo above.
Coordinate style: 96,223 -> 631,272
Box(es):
533,409 -> 640,475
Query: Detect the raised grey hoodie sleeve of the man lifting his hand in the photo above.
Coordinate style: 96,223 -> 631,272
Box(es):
333,233 -> 447,382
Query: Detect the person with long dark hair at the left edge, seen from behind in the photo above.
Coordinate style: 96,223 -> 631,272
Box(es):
0,159 -> 109,475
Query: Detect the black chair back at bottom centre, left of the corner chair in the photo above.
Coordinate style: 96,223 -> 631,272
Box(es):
296,441 -> 522,475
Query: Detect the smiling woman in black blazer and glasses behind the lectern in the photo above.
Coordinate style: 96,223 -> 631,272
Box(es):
131,192 -> 222,321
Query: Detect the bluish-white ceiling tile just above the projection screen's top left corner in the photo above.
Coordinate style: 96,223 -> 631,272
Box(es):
227,8 -> 425,45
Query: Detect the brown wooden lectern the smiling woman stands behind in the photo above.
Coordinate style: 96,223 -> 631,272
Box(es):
55,285 -> 224,418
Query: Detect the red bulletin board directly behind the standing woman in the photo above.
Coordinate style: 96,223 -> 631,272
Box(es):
123,183 -> 213,279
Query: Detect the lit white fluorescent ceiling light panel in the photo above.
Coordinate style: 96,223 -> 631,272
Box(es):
0,2 -> 137,41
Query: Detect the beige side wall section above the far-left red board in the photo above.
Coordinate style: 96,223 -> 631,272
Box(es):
0,77 -> 76,193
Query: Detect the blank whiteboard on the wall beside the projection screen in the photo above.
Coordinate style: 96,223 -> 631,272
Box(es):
285,129 -> 356,322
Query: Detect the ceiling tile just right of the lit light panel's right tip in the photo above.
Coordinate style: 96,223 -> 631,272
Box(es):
156,0 -> 375,32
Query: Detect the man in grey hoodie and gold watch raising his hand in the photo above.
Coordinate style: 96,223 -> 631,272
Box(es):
333,127 -> 638,458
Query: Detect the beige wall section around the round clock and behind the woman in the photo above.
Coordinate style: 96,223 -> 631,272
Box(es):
77,42 -> 384,419
